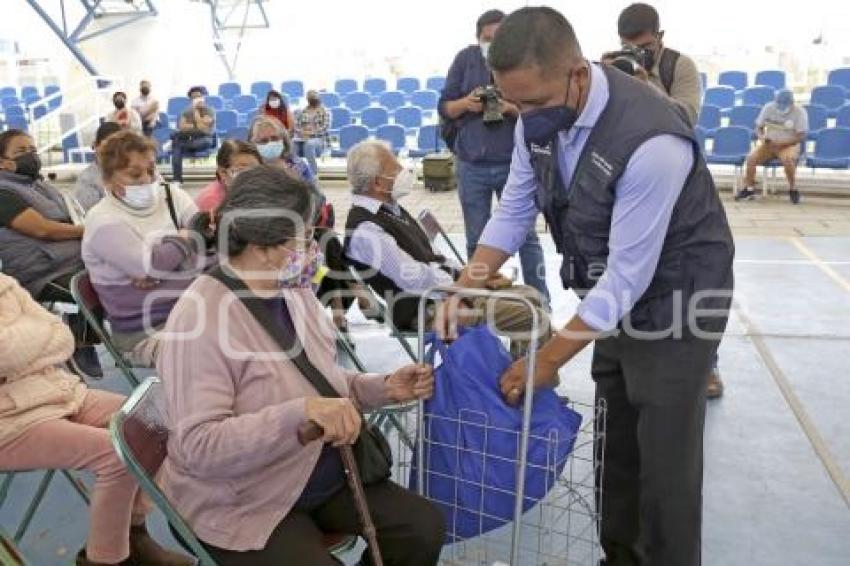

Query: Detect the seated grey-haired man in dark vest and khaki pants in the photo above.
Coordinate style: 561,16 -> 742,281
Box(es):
343,140 -> 549,355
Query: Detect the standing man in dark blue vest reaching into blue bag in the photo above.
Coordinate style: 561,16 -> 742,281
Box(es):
437,7 -> 734,566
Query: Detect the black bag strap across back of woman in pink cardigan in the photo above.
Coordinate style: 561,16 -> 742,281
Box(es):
207,266 -> 341,397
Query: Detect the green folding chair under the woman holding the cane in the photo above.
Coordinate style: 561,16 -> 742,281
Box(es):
109,377 -> 357,566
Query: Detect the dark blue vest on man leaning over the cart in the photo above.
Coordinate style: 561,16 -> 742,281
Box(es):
529,66 -> 734,331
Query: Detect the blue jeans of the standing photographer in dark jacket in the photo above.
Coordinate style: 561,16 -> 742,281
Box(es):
457,160 -> 549,303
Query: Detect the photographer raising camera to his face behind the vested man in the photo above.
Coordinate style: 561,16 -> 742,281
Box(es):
602,3 -> 702,125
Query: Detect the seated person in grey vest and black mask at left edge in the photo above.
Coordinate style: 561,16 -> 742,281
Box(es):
0,129 -> 103,377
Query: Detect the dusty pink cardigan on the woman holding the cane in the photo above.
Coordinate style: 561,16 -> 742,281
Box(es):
157,276 -> 387,551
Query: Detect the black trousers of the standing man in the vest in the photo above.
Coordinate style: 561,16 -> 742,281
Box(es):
591,330 -> 725,566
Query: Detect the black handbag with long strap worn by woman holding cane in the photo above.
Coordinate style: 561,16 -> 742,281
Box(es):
208,267 -> 392,485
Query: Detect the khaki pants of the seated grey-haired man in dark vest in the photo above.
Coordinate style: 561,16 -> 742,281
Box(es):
413,285 -> 552,358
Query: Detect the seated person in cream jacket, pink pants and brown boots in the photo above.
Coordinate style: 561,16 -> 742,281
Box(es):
0,274 -> 193,566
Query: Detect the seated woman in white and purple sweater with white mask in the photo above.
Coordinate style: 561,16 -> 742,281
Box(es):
82,132 -> 203,367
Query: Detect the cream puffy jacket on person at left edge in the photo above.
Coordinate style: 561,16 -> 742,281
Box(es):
0,274 -> 86,446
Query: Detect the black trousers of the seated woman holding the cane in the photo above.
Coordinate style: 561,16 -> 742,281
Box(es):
203,482 -> 445,566
